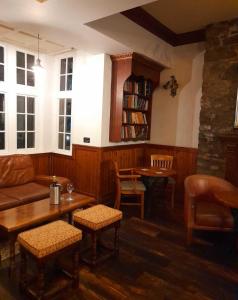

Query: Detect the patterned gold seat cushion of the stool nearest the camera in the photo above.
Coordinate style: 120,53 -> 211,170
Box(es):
17,221 -> 82,258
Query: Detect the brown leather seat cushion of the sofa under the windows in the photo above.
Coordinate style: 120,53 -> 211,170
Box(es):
1,182 -> 50,205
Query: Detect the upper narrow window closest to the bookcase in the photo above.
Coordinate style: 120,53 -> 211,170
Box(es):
60,57 -> 73,91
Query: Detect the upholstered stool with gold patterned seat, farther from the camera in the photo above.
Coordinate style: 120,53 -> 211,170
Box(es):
73,204 -> 122,266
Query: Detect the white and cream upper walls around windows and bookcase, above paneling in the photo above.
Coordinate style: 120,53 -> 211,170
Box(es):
0,43 -> 203,155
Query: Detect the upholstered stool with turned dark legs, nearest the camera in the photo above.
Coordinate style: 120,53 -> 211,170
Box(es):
17,221 -> 82,299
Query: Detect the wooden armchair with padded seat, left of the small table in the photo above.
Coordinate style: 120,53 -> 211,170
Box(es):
114,161 -> 146,219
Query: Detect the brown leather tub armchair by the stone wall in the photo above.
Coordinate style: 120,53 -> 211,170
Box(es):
184,174 -> 236,245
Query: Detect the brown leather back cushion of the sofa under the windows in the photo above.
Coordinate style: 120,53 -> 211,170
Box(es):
0,154 -> 35,188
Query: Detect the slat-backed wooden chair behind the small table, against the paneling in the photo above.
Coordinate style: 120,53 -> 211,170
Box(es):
150,154 -> 176,208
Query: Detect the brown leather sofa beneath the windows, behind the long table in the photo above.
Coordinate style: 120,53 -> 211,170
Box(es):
0,155 -> 69,210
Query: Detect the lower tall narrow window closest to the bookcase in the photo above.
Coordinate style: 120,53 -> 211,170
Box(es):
58,98 -> 72,150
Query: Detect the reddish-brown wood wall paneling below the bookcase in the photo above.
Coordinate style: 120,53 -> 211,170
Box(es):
48,143 -> 197,210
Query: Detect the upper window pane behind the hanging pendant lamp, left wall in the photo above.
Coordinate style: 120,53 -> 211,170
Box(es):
17,51 -> 35,86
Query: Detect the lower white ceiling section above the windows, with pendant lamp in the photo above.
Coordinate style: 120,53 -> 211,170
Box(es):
0,0 -> 152,54
